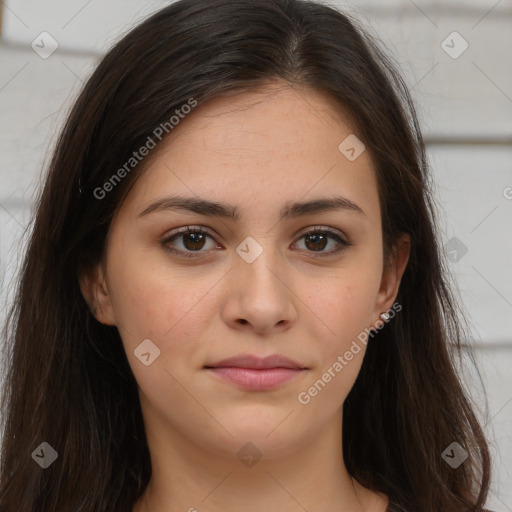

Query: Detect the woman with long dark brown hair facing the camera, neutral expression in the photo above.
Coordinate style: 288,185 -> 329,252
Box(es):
0,0 -> 490,512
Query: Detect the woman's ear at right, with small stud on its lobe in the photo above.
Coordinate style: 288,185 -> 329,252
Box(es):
372,233 -> 411,325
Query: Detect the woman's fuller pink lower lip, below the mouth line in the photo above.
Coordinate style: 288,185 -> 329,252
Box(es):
208,366 -> 304,391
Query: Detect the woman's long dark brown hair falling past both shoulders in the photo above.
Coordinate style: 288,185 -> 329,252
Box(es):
0,0 -> 490,512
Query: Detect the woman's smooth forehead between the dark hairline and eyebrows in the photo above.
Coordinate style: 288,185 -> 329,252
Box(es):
119,83 -> 379,223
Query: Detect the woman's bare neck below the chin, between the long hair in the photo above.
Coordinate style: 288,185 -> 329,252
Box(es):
133,408 -> 387,512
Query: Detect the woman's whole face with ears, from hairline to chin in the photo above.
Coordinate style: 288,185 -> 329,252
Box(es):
85,83 -> 407,457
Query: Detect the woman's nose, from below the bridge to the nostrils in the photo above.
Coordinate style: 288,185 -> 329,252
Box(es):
222,247 -> 299,335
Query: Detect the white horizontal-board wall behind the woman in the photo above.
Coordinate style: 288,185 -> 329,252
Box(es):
0,0 -> 512,512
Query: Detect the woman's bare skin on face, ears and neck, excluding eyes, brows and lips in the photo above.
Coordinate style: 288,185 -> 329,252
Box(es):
81,82 -> 409,512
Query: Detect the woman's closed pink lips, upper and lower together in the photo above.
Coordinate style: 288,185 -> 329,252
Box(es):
205,354 -> 306,391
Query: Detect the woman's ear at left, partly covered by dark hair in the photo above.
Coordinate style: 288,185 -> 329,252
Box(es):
78,263 -> 116,325
